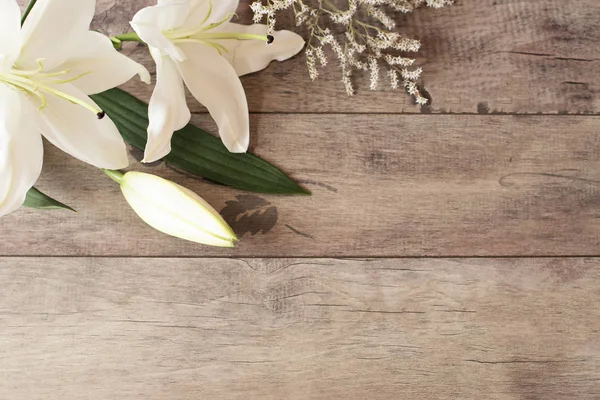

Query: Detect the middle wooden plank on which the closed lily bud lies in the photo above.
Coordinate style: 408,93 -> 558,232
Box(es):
0,114 -> 600,257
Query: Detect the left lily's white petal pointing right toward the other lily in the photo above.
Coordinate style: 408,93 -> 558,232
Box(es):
58,31 -> 150,94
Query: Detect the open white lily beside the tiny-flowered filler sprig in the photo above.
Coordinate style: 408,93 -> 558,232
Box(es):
131,0 -> 304,162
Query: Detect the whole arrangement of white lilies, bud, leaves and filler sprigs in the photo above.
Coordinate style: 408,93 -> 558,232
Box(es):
0,0 -> 449,247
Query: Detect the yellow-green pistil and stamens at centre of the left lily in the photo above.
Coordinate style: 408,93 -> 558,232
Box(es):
0,60 -> 106,119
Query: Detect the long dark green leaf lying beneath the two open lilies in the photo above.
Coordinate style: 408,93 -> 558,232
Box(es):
91,89 -> 310,195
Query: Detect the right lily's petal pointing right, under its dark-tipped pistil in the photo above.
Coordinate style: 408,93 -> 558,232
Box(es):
218,23 -> 304,76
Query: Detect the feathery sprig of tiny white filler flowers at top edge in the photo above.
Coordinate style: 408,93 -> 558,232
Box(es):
251,0 -> 453,105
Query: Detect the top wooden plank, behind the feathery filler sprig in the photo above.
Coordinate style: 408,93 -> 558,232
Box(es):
90,0 -> 600,114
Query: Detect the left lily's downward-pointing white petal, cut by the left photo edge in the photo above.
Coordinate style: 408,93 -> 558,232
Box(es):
0,83 -> 44,215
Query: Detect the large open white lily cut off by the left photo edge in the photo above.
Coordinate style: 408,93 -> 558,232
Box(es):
0,0 -> 150,215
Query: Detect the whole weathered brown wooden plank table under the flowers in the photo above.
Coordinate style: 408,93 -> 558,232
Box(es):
0,0 -> 600,400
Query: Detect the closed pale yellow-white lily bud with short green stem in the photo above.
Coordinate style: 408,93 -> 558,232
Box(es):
104,170 -> 238,247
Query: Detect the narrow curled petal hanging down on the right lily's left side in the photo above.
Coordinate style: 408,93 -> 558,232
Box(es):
143,49 -> 191,162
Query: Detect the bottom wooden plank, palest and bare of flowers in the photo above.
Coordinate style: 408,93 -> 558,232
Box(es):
0,258 -> 600,400
